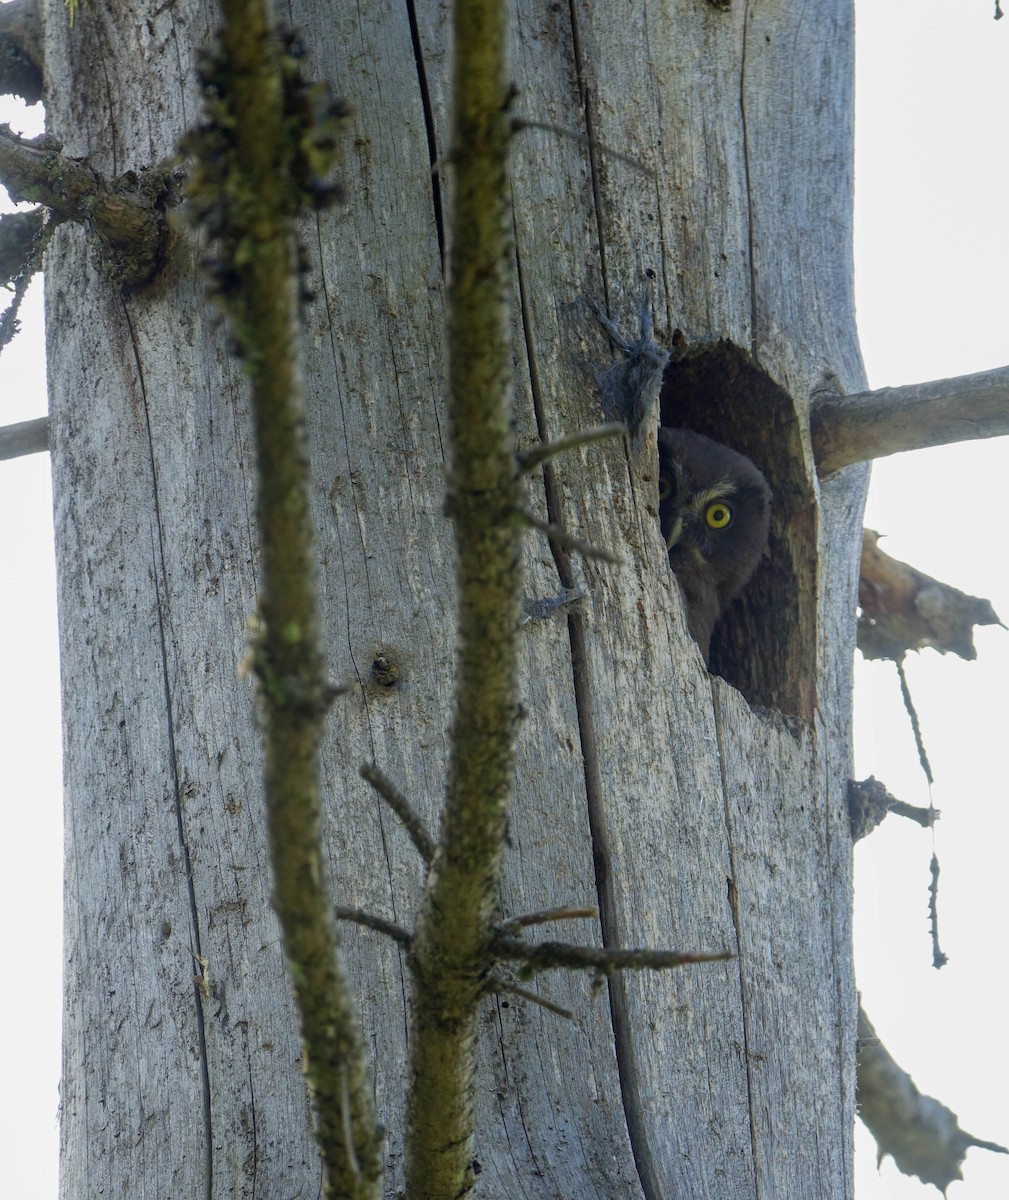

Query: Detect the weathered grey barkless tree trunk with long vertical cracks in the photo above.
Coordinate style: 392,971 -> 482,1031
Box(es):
46,0 -> 865,1200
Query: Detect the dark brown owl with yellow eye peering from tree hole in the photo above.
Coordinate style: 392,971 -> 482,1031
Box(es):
659,426 -> 770,665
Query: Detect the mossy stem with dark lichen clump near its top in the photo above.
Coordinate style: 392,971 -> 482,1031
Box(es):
187,9 -> 382,1200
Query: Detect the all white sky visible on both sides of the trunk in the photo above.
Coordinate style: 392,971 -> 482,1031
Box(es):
0,0 -> 1009,1200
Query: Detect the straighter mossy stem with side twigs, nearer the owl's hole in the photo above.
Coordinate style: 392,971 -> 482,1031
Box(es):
406,0 -> 523,1200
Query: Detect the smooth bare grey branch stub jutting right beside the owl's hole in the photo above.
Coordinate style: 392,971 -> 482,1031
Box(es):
810,367 -> 1009,475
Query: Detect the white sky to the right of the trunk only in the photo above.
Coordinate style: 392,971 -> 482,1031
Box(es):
855,0 -> 1009,1200
